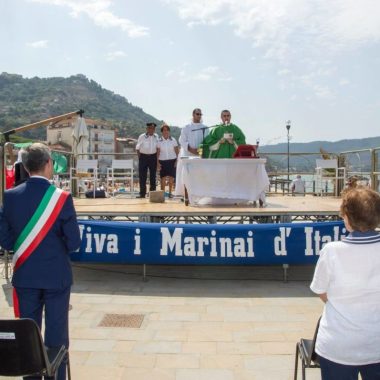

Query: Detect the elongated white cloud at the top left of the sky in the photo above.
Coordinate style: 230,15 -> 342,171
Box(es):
29,0 -> 149,38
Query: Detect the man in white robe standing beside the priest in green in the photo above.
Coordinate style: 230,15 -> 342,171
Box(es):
175,108 -> 208,196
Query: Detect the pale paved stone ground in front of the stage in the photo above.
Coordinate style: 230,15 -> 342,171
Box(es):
0,265 -> 323,380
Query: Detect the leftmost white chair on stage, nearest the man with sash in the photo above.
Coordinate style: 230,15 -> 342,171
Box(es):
70,159 -> 98,197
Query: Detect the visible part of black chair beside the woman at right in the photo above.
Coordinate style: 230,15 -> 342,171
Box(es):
294,318 -> 321,380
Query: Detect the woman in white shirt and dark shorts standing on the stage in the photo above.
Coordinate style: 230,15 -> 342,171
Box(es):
157,124 -> 179,198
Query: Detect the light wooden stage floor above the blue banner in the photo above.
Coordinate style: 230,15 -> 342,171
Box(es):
74,195 -> 341,224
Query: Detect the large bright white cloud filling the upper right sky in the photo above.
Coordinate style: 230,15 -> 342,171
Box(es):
164,0 -> 380,99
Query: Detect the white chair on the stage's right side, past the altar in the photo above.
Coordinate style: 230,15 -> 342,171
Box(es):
315,158 -> 346,195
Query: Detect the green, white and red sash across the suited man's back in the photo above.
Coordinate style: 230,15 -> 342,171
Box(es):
13,185 -> 69,271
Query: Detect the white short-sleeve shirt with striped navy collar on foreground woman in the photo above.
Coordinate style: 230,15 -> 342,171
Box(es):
310,232 -> 380,365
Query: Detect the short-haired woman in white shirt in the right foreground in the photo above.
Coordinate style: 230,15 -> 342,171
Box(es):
310,187 -> 380,380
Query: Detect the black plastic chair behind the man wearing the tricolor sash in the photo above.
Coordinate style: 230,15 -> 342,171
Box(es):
0,318 -> 71,379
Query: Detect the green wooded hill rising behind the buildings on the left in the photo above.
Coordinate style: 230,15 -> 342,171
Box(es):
0,73 -> 179,139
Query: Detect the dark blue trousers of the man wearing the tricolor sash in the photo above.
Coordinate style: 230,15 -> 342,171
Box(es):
16,286 -> 71,380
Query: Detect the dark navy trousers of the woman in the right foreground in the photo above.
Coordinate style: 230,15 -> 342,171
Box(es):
319,357 -> 380,380
